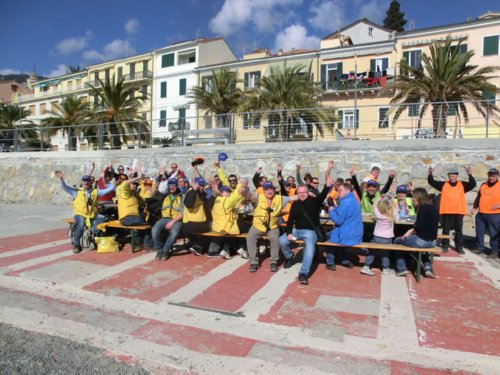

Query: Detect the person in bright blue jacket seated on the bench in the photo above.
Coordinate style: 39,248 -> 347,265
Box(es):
326,183 -> 363,271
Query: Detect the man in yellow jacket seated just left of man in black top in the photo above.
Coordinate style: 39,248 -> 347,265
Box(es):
247,181 -> 297,272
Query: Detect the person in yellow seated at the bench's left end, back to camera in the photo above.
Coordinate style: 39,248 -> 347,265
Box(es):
116,171 -> 153,248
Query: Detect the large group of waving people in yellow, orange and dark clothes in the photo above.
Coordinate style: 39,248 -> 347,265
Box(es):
55,154 -> 500,284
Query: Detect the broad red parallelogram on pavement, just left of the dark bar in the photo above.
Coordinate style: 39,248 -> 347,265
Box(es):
84,254 -> 222,302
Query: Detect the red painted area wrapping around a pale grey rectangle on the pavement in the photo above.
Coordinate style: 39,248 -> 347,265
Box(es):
259,264 -> 380,338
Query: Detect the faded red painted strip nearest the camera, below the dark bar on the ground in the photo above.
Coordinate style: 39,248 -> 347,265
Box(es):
132,321 -> 256,357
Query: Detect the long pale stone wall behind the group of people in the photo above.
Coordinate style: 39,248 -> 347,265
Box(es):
0,139 -> 500,205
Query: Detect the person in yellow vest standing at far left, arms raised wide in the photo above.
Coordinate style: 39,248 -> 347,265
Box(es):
55,171 -> 115,254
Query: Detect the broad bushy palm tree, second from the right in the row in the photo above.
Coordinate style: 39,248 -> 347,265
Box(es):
241,61 -> 335,141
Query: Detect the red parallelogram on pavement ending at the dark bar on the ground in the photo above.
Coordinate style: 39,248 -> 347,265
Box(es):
188,259 -> 274,312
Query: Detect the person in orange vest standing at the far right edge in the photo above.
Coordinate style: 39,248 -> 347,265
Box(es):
471,168 -> 500,259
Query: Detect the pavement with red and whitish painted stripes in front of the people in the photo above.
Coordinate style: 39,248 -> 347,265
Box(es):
0,204 -> 500,374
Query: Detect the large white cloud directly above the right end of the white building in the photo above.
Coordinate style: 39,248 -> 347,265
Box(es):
209,0 -> 302,37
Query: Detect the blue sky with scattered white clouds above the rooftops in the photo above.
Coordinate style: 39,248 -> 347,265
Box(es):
0,0 -> 500,76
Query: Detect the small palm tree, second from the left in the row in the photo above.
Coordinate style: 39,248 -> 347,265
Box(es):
41,96 -> 92,150
